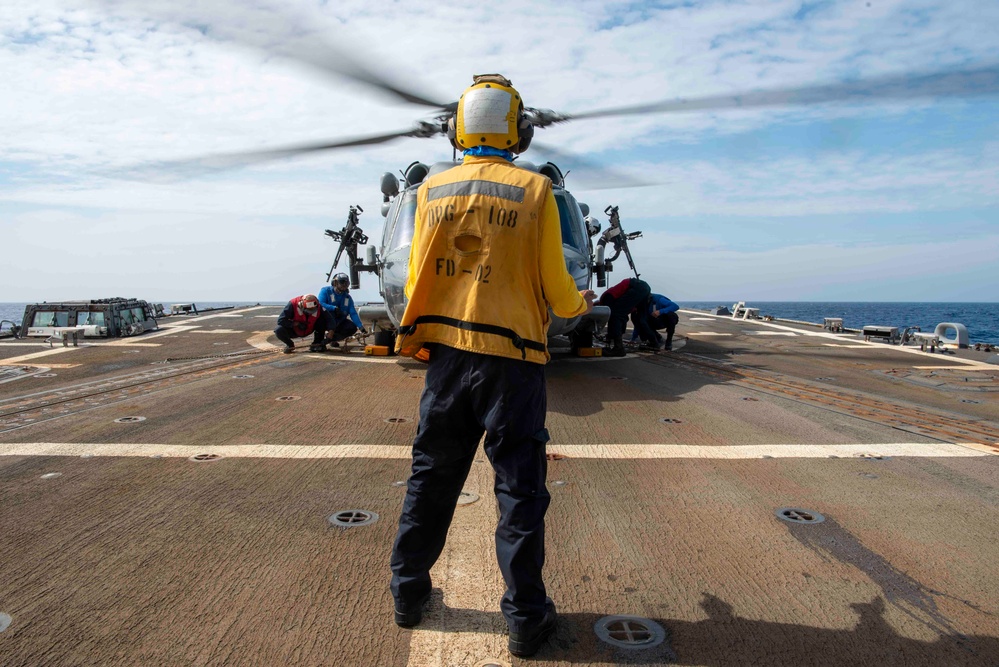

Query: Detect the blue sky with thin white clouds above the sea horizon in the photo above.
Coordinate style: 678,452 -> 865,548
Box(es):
0,0 -> 999,303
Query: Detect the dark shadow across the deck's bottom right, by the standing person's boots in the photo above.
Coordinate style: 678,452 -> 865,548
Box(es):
408,591 -> 999,667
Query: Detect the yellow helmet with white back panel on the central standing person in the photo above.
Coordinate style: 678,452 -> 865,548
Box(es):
448,74 -> 534,153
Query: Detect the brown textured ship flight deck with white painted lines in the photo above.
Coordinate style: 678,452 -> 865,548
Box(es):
0,307 -> 999,666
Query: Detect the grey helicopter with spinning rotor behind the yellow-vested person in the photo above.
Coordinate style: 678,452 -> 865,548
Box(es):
123,6 -> 999,354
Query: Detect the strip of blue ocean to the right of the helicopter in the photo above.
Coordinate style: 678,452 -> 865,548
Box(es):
678,301 -> 999,345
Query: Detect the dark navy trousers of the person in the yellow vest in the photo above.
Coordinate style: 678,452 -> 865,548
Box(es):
391,345 -> 551,632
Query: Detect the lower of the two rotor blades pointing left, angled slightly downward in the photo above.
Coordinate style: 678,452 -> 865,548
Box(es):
103,129 -> 423,182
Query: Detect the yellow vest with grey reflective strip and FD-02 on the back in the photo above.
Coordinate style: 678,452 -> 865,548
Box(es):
396,158 -> 586,364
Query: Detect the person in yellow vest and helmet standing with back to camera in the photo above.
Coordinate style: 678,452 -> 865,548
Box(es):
391,74 -> 594,655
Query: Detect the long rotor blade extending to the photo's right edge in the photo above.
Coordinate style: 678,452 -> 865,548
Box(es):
566,65 -> 999,120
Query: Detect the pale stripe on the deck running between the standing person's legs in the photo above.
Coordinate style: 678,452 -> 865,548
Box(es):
407,460 -> 509,666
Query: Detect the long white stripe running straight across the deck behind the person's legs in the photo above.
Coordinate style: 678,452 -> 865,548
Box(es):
0,444 -> 990,460
